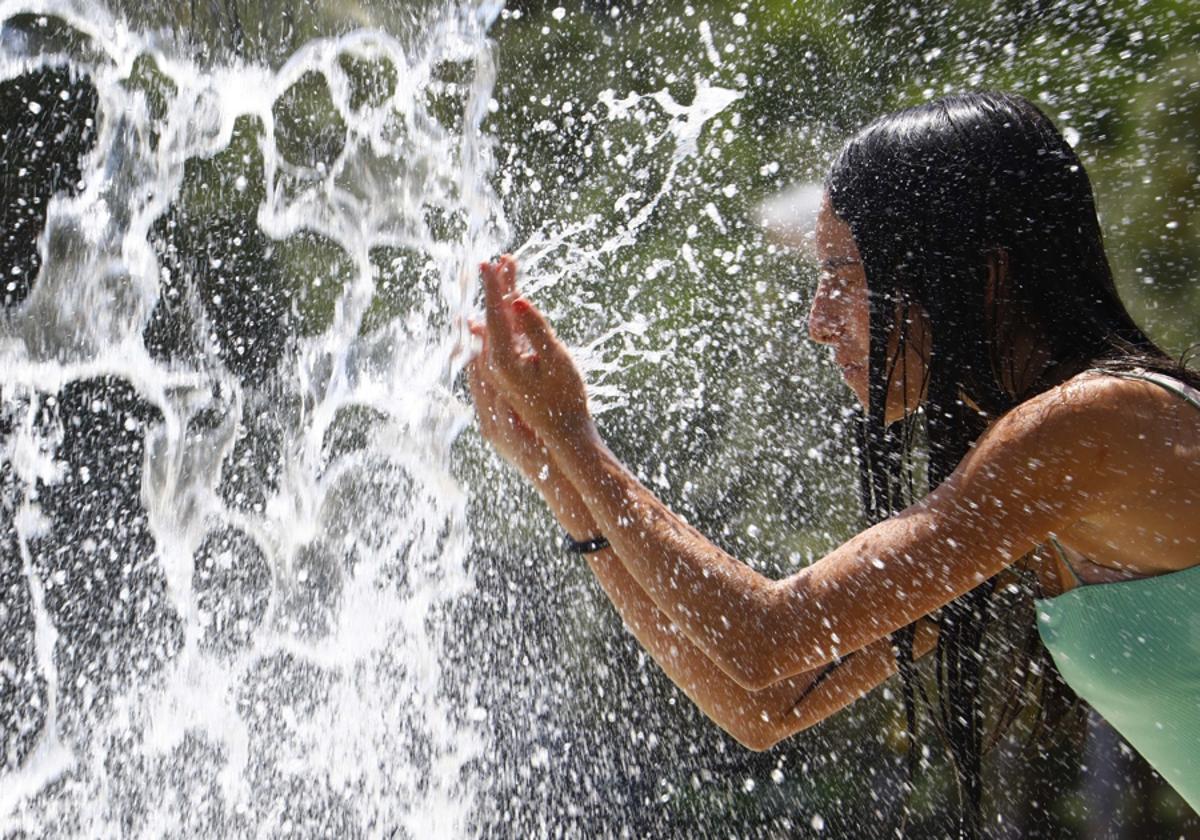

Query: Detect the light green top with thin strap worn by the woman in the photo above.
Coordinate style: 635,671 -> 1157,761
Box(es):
1037,373 -> 1200,811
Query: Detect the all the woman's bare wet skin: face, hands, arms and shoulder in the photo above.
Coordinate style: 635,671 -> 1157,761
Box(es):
470,201 -> 1200,749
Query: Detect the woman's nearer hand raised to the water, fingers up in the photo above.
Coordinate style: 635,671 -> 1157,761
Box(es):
480,254 -> 594,448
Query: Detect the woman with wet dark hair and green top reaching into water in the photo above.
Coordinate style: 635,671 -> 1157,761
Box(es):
470,94 -> 1200,834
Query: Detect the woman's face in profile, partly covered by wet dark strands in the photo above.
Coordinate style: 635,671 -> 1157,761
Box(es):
809,194 -> 929,422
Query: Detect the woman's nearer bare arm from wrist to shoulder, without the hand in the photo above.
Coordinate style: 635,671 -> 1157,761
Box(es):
547,374 -> 1128,690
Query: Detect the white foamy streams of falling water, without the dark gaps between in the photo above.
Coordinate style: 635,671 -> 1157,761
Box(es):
0,0 -> 496,836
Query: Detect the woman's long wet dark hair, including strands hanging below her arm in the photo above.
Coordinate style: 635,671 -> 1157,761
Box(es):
826,92 -> 1200,836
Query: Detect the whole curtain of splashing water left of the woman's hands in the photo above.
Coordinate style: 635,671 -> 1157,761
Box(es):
0,2 -> 504,836
